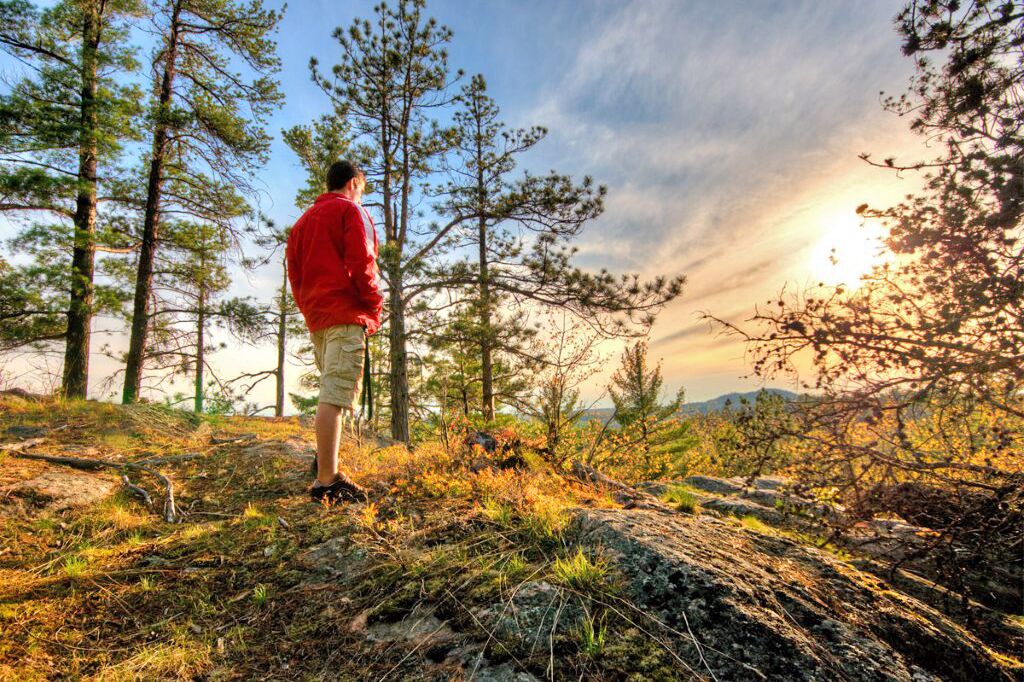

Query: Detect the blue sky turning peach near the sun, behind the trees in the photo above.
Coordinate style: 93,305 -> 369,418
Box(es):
0,0 -> 922,404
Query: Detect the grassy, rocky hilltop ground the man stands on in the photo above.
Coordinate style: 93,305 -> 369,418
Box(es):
0,397 -> 1024,682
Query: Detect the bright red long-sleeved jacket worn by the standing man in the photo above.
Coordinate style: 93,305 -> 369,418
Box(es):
285,193 -> 384,334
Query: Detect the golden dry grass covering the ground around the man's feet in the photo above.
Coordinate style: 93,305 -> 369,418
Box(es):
0,398 -> 613,680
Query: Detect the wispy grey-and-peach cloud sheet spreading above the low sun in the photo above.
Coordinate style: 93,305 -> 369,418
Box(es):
507,0 -> 913,395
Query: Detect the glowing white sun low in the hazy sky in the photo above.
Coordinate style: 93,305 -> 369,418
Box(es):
810,213 -> 884,287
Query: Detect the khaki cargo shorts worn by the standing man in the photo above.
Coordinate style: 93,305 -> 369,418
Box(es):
309,325 -> 367,412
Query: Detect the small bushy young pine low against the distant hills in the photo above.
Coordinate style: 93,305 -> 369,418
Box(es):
608,341 -> 696,478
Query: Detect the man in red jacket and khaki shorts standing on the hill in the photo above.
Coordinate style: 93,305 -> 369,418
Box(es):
286,161 -> 384,503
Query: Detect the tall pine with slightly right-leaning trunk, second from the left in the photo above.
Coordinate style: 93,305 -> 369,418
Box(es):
122,0 -> 282,403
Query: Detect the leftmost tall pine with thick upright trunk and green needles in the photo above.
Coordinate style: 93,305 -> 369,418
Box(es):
0,0 -> 141,397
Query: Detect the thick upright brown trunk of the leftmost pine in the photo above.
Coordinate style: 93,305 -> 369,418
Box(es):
61,7 -> 100,398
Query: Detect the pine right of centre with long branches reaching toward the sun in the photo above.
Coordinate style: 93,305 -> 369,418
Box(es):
437,75 -> 682,420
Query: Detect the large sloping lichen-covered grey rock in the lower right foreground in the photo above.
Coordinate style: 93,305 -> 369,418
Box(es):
577,509 -> 1020,682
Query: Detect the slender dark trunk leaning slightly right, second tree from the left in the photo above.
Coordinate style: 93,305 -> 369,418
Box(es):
121,0 -> 181,404
